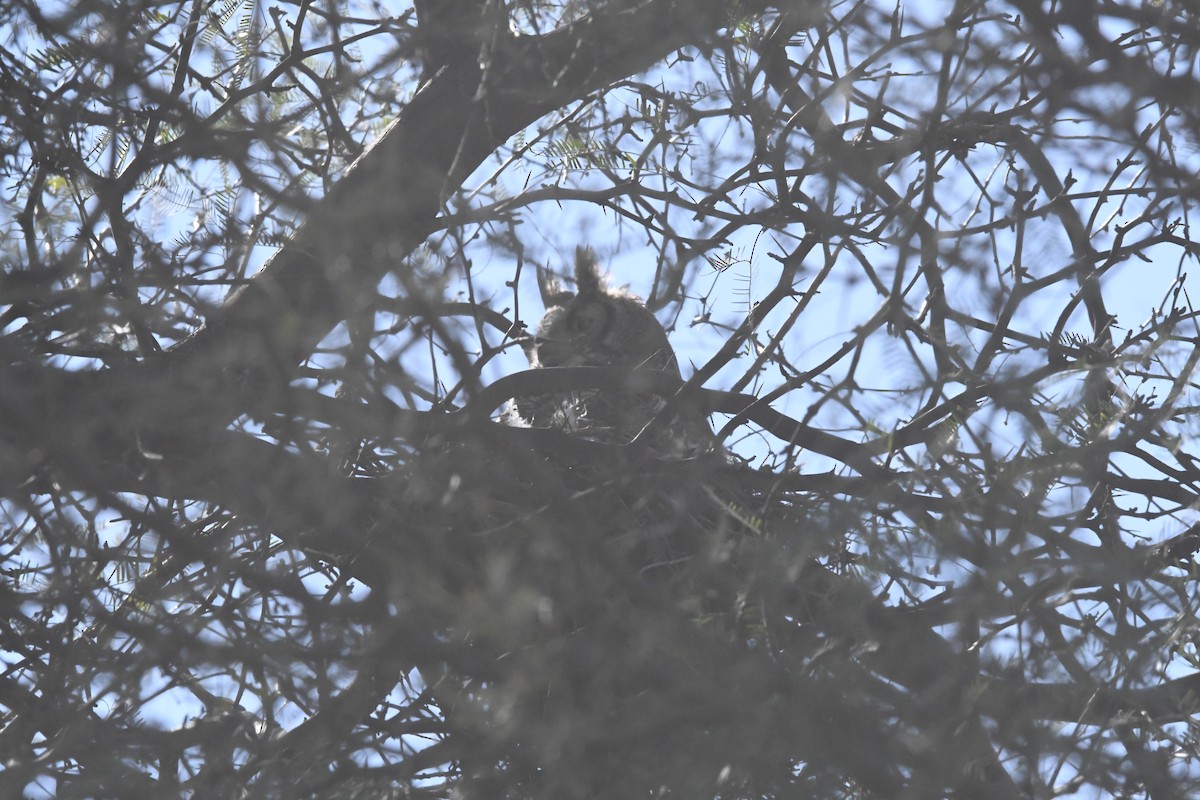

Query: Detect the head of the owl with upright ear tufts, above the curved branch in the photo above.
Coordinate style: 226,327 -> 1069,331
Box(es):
527,247 -> 679,377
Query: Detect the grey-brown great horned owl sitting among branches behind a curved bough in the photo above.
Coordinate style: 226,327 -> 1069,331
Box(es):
512,247 -> 713,458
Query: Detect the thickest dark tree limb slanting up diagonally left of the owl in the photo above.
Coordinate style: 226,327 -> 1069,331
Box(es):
30,0 -> 787,450
